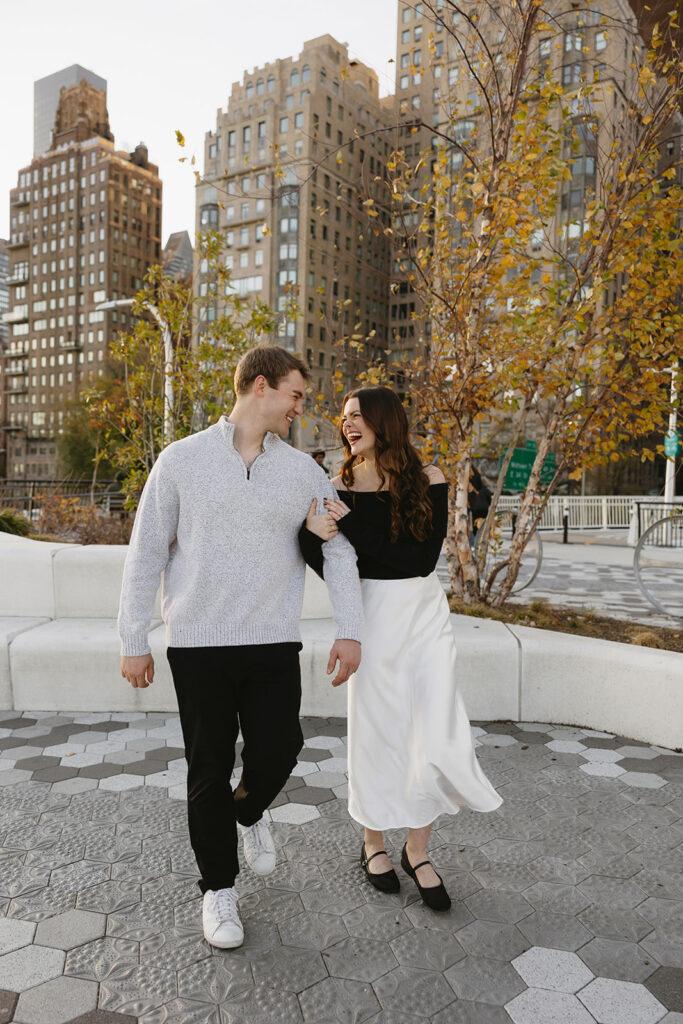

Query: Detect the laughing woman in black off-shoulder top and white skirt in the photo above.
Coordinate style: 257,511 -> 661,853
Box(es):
300,387 -> 502,910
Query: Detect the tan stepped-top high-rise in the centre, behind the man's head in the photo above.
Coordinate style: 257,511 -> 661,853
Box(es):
197,35 -> 394,445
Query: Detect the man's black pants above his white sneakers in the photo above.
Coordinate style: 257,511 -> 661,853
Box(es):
168,643 -> 303,892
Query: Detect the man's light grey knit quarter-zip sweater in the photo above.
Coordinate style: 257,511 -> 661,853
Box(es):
119,417 -> 361,655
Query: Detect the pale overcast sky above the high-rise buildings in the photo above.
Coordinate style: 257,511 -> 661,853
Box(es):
0,0 -> 398,244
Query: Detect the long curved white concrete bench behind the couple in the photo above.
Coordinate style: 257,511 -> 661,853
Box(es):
0,534 -> 683,748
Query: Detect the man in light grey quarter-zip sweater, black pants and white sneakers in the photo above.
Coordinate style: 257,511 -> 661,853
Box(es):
119,345 -> 361,948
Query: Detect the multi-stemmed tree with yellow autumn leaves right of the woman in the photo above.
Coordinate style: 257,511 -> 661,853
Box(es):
378,0 -> 683,604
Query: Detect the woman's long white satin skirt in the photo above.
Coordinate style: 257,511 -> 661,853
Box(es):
348,572 -> 503,830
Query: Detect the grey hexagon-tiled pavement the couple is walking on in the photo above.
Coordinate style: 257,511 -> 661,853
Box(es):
0,712 -> 683,1024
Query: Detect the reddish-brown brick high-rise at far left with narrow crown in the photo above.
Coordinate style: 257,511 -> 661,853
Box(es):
0,80 -> 162,479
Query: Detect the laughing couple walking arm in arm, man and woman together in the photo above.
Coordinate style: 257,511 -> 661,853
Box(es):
119,345 -> 501,948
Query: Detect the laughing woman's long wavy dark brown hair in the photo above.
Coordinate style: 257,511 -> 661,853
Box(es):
339,387 -> 432,541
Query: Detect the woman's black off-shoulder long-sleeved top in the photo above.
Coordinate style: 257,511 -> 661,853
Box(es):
299,483 -> 449,580
